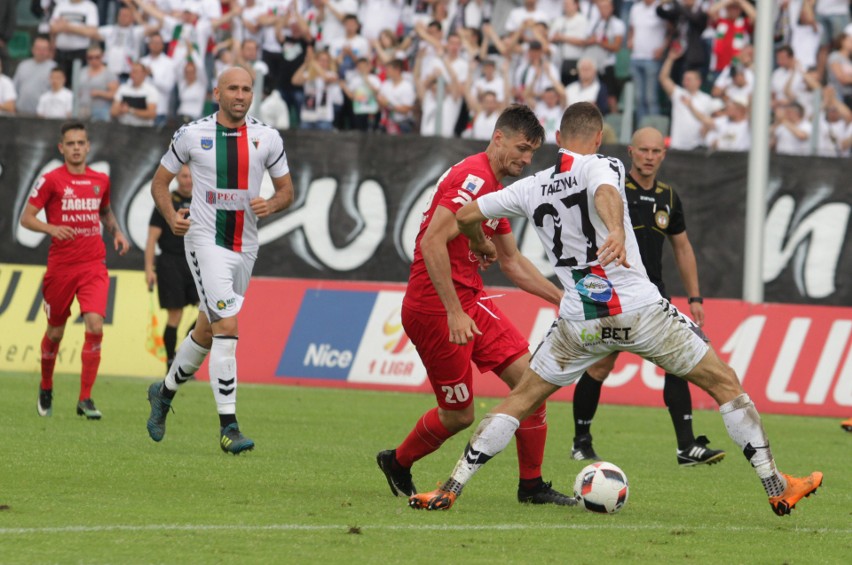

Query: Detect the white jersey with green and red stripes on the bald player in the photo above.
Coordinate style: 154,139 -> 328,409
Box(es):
160,114 -> 290,253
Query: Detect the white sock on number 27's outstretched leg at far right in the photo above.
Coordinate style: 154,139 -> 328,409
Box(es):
719,393 -> 787,496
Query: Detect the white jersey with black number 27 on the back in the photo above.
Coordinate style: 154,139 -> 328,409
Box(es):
478,149 -> 660,320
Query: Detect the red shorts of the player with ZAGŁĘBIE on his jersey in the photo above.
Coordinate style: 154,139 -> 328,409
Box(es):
41,262 -> 109,326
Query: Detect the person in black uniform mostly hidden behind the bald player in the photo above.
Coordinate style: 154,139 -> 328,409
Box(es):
145,165 -> 198,371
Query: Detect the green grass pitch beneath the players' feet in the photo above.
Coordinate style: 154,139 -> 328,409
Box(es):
0,374 -> 852,564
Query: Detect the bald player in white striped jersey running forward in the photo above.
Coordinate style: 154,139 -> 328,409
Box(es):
147,67 -> 293,455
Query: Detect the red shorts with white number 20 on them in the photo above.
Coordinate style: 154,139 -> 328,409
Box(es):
402,299 -> 529,410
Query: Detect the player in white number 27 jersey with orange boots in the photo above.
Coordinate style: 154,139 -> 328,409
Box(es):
409,102 -> 822,516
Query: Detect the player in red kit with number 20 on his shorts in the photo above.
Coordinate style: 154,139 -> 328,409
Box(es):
376,105 -> 576,506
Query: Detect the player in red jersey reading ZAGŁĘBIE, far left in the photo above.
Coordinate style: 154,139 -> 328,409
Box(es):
21,122 -> 130,420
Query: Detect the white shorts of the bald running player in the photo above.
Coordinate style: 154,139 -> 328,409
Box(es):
184,239 -> 257,323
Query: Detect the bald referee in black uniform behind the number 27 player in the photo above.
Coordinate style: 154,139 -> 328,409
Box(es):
571,128 -> 725,466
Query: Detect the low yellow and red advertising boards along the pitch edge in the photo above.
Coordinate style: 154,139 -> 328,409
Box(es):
0,265 -> 852,416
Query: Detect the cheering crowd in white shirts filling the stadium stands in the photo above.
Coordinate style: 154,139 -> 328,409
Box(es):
0,0 -> 852,157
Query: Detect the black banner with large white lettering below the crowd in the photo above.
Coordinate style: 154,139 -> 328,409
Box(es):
0,119 -> 852,306
